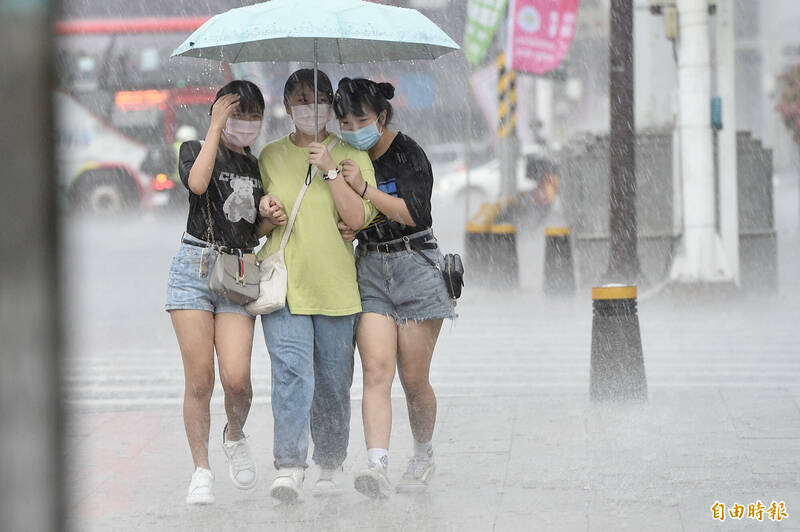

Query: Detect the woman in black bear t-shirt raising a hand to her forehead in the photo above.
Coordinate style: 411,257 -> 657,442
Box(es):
166,80 -> 286,504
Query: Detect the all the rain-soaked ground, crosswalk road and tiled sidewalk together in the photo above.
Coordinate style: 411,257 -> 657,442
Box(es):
64,178 -> 800,531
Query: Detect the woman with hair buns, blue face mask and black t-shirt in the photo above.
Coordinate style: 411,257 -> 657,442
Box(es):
334,78 -> 455,498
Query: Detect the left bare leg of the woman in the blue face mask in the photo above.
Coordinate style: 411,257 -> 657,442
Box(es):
356,312 -> 397,449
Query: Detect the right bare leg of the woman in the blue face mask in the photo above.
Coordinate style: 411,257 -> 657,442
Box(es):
397,319 -> 443,443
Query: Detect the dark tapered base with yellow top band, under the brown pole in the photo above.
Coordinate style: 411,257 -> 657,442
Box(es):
589,285 -> 647,402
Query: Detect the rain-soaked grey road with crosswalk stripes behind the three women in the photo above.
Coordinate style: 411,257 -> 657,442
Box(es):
63,177 -> 800,408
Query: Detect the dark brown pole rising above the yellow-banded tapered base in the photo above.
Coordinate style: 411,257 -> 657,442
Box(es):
606,0 -> 640,283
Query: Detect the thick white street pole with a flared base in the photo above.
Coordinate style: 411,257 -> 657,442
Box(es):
670,0 -> 731,283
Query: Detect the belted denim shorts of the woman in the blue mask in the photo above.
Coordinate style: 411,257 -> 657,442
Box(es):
356,240 -> 456,325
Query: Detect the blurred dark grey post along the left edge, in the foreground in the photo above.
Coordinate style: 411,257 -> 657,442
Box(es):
0,0 -> 63,531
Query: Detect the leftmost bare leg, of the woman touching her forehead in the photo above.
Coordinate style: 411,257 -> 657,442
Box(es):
170,310 -> 214,469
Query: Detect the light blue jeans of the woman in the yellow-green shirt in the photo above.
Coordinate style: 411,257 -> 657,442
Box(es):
261,305 -> 358,468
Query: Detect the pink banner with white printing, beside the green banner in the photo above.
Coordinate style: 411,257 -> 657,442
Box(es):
508,0 -> 580,74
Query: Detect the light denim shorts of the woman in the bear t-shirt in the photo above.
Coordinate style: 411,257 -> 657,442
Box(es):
165,234 -> 254,318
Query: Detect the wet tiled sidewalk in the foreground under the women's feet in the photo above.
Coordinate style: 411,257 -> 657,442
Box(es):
69,389 -> 800,531
